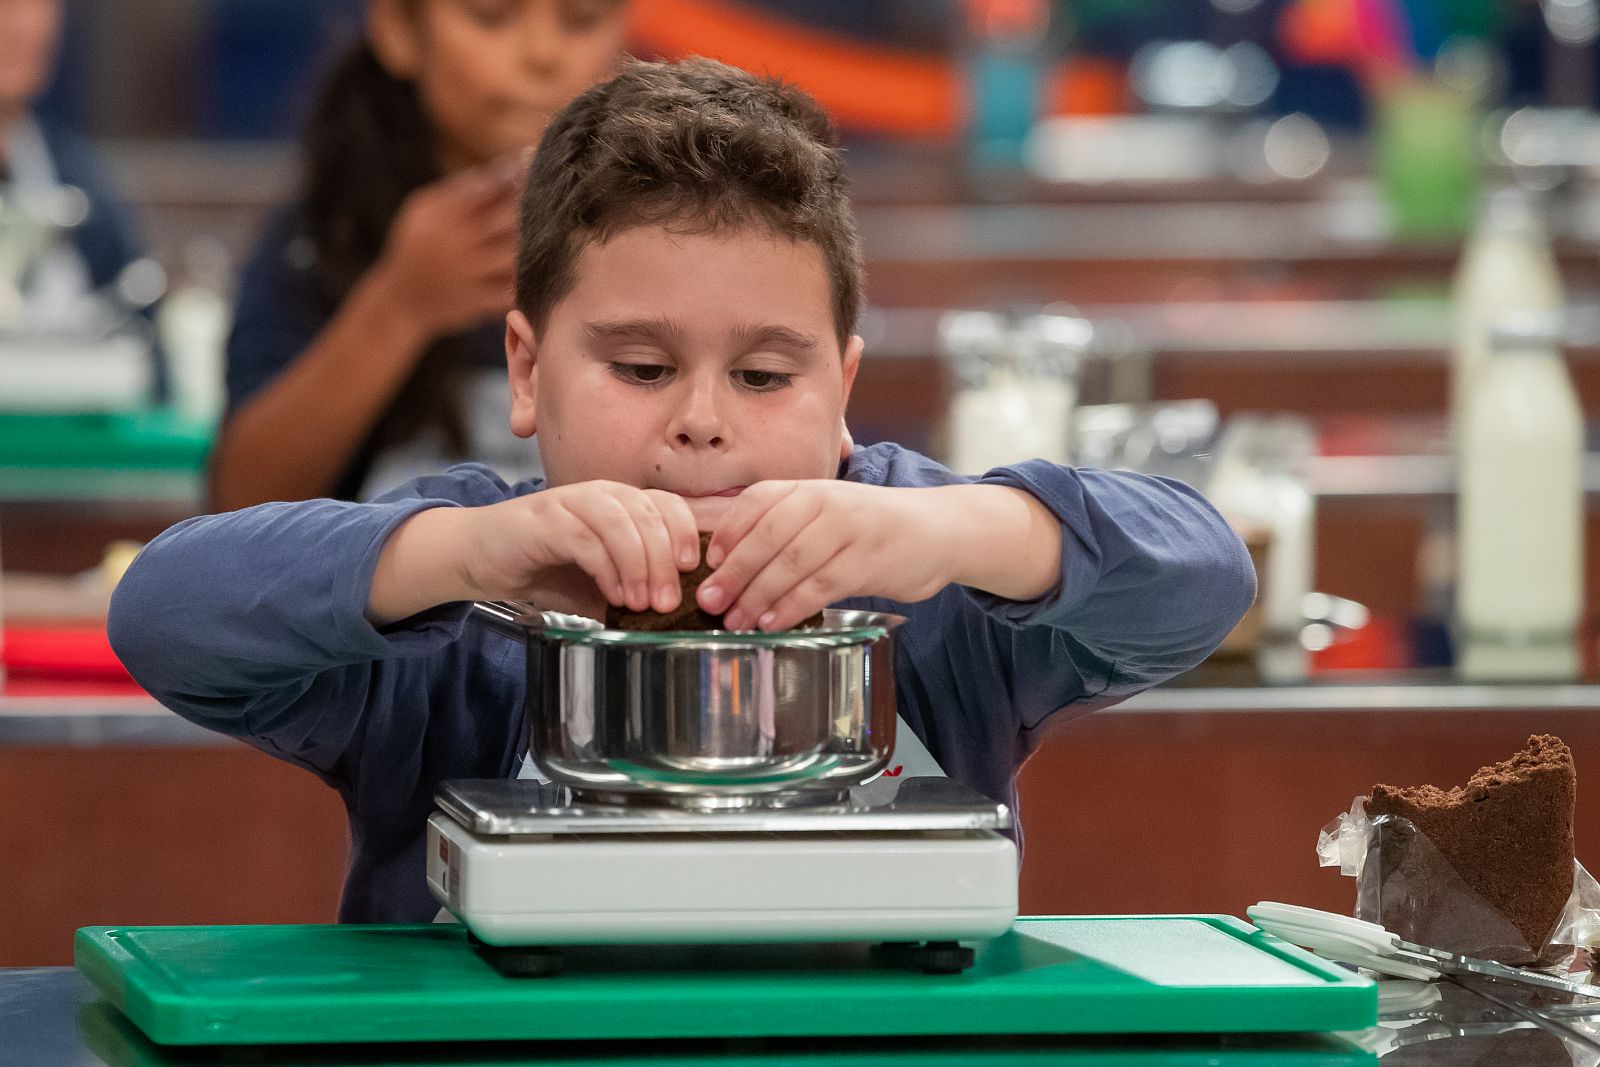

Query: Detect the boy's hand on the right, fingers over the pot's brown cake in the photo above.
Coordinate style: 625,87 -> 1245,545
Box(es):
698,478 -> 957,630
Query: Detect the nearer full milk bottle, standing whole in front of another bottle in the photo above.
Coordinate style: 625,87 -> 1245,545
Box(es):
1456,312 -> 1584,680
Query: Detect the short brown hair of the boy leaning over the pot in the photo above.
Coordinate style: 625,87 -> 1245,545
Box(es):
517,59 -> 862,346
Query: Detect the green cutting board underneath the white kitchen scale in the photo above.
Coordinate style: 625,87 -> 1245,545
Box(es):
74,915 -> 1378,1045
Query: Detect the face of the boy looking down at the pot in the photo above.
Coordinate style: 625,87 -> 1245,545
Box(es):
506,226 -> 861,530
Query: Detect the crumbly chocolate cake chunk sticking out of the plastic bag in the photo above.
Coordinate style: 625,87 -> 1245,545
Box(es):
1366,734 -> 1578,953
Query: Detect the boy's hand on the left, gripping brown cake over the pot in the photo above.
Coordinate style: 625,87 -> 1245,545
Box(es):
464,482 -> 699,611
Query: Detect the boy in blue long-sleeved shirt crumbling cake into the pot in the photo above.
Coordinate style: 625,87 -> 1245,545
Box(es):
110,61 -> 1254,921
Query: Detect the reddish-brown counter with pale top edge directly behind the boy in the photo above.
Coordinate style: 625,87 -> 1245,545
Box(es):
0,675 -> 1600,966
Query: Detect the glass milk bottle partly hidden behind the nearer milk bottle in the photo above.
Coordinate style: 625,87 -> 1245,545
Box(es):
1450,189 -> 1565,435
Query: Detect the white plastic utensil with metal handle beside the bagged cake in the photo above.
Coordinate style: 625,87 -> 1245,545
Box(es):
1245,901 -> 1600,997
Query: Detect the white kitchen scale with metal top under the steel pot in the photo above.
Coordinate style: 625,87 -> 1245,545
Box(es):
427,777 -> 1018,974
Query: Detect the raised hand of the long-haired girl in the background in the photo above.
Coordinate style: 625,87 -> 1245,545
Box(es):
373,155 -> 525,338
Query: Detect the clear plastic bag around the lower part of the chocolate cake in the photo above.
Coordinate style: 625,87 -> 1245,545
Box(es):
1317,797 -> 1600,973
